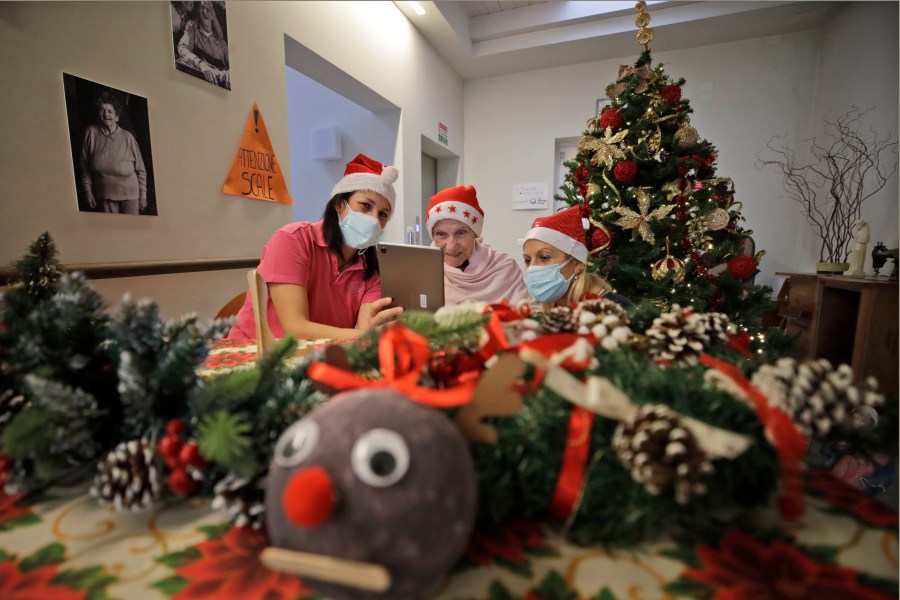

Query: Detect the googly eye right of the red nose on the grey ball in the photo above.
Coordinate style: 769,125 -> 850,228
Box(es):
351,429 -> 409,487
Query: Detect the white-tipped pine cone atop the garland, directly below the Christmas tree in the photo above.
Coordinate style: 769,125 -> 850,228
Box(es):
646,304 -> 718,365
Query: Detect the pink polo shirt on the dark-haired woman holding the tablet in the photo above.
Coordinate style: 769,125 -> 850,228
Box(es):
228,221 -> 381,339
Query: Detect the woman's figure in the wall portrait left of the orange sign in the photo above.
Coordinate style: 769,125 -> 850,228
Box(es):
81,92 -> 147,215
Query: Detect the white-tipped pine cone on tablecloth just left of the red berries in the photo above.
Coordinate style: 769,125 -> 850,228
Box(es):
91,439 -> 162,511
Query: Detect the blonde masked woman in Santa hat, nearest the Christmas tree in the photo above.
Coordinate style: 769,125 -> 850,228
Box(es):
522,206 -> 631,312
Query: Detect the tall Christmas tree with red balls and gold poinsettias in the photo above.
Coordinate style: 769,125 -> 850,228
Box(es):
556,2 -> 771,325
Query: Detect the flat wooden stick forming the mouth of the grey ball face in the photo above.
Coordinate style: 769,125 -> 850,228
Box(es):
259,546 -> 391,592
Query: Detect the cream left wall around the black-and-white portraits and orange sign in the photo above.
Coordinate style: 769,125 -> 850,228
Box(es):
0,1 -> 464,316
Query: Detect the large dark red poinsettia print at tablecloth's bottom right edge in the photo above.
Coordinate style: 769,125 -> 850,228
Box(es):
683,529 -> 885,600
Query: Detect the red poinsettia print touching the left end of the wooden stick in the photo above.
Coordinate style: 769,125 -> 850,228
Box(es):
172,527 -> 310,600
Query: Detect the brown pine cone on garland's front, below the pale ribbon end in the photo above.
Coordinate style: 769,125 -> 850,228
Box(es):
613,405 -> 712,504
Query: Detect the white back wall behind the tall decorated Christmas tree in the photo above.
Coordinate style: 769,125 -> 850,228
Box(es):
463,2 -> 898,285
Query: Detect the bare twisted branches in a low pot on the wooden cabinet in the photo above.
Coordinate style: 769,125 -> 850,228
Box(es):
756,106 -> 898,270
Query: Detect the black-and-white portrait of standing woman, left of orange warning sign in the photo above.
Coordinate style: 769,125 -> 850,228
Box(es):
63,74 -> 157,215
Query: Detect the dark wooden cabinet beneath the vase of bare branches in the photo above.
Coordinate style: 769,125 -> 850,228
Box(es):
778,273 -> 900,393
